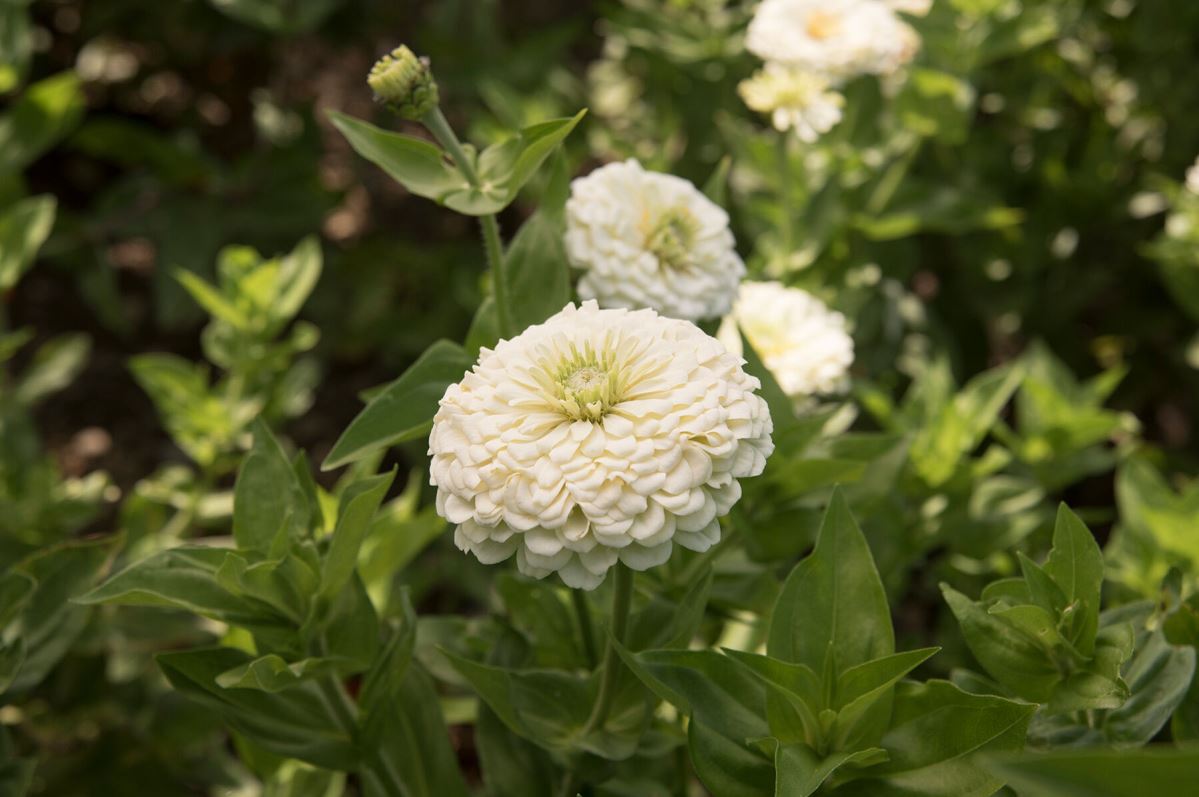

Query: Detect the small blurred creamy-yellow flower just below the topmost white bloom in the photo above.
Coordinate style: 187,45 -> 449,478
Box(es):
737,64 -> 845,144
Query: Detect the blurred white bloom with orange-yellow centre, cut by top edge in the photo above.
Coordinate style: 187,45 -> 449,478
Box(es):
746,0 -> 920,78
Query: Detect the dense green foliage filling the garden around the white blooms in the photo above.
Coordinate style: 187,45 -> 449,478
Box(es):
0,0 -> 1199,797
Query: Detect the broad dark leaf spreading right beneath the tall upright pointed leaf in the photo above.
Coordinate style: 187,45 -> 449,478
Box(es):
837,681 -> 1036,797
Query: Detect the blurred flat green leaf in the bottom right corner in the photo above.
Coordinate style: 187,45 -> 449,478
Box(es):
983,747 -> 1199,797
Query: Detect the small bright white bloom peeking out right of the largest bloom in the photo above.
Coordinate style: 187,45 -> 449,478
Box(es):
717,282 -> 854,400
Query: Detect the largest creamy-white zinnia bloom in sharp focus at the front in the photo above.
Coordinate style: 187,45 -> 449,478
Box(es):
429,302 -> 773,590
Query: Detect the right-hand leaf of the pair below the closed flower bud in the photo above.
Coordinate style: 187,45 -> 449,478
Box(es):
477,109 -> 588,214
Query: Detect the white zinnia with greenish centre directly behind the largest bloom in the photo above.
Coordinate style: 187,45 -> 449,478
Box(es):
566,159 -> 745,321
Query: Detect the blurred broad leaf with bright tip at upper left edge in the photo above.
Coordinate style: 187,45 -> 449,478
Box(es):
0,72 -> 85,176
